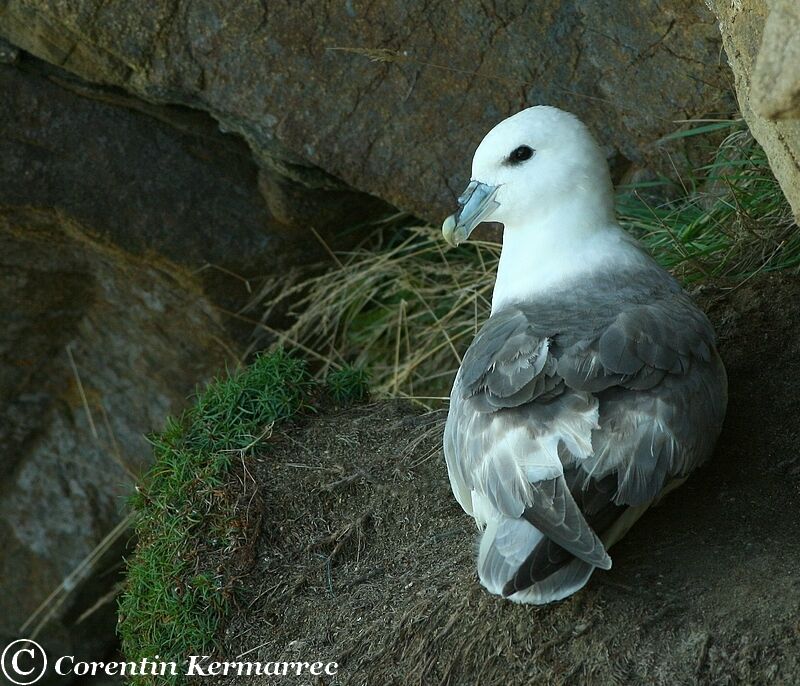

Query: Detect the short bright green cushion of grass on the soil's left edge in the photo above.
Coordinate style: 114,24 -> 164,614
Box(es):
119,350 -> 313,686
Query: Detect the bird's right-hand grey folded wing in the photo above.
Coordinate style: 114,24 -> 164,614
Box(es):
558,292 -> 727,505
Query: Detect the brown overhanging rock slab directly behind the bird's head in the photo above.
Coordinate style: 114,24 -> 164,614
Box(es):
0,0 -> 729,221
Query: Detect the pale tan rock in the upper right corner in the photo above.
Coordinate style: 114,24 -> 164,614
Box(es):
707,0 -> 800,220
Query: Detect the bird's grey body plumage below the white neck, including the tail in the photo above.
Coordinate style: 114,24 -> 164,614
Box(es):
445,263 -> 726,602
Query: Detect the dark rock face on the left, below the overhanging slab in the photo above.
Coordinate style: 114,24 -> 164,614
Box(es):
0,57 -> 384,657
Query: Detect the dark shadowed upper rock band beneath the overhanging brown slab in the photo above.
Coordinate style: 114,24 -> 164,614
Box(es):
0,59 -> 382,312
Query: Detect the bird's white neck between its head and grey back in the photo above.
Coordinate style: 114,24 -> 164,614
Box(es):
492,198 -> 648,313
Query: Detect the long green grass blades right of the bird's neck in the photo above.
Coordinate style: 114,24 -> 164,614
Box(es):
617,120 -> 800,283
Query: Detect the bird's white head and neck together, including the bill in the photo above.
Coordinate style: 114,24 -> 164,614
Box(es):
442,107 -> 649,312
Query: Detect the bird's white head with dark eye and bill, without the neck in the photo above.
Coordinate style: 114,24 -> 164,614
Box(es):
442,106 -> 614,245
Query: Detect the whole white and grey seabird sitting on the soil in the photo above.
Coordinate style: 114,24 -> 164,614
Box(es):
442,107 -> 727,604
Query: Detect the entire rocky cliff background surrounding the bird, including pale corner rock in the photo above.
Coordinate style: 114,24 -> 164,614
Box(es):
0,0 -> 800,668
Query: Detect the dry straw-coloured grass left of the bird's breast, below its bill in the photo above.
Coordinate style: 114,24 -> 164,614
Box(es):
250,226 -> 500,402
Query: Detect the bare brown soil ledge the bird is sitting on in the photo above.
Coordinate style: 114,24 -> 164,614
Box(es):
202,276 -> 800,686
